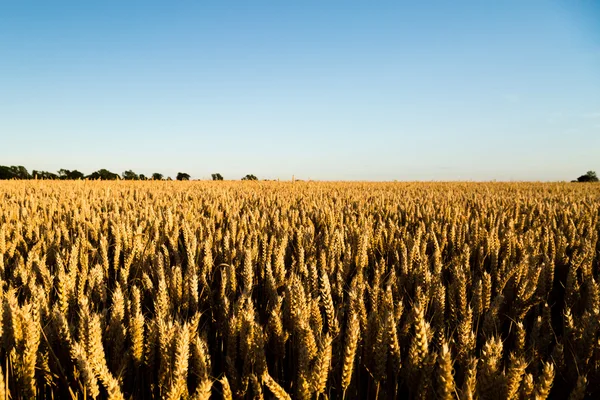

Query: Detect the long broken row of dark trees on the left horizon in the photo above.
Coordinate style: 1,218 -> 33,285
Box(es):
0,165 -> 258,181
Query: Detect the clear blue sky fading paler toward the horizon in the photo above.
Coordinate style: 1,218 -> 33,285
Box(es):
0,0 -> 600,180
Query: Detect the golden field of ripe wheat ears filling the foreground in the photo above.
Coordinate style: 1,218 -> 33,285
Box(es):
0,181 -> 600,400
